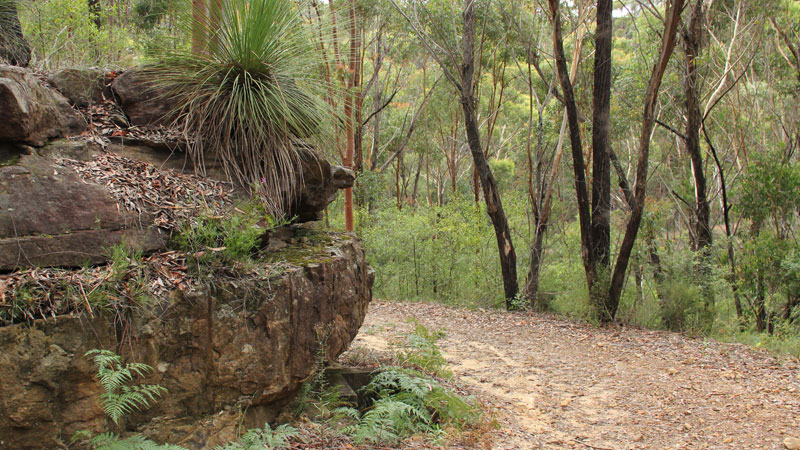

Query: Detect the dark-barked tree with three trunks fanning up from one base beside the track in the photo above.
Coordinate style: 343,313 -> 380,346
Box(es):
548,0 -> 683,321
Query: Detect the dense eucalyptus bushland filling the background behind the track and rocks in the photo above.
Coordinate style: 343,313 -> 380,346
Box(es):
3,0 -> 800,353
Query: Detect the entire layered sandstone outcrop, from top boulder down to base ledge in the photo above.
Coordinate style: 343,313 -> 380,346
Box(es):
0,66 -> 373,449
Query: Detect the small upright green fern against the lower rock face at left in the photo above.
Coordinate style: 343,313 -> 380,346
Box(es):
85,349 -> 167,425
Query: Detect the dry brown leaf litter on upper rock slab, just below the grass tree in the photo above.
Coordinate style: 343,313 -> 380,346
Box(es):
58,153 -> 233,230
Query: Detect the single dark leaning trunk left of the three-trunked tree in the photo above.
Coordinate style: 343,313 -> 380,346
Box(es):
461,0 -> 519,308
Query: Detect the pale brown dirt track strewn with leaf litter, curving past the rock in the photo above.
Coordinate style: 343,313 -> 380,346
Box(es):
347,301 -> 800,450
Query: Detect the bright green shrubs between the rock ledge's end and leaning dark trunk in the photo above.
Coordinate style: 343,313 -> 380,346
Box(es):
359,197 -> 524,306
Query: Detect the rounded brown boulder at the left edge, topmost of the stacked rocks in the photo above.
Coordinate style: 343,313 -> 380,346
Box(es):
0,64 -> 86,146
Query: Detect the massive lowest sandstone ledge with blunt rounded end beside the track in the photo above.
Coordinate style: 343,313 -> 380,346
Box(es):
0,230 -> 373,449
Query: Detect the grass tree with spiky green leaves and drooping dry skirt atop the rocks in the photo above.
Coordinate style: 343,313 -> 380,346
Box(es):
148,0 -> 330,217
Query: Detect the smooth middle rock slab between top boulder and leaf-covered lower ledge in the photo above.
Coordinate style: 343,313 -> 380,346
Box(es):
0,148 -> 167,270
